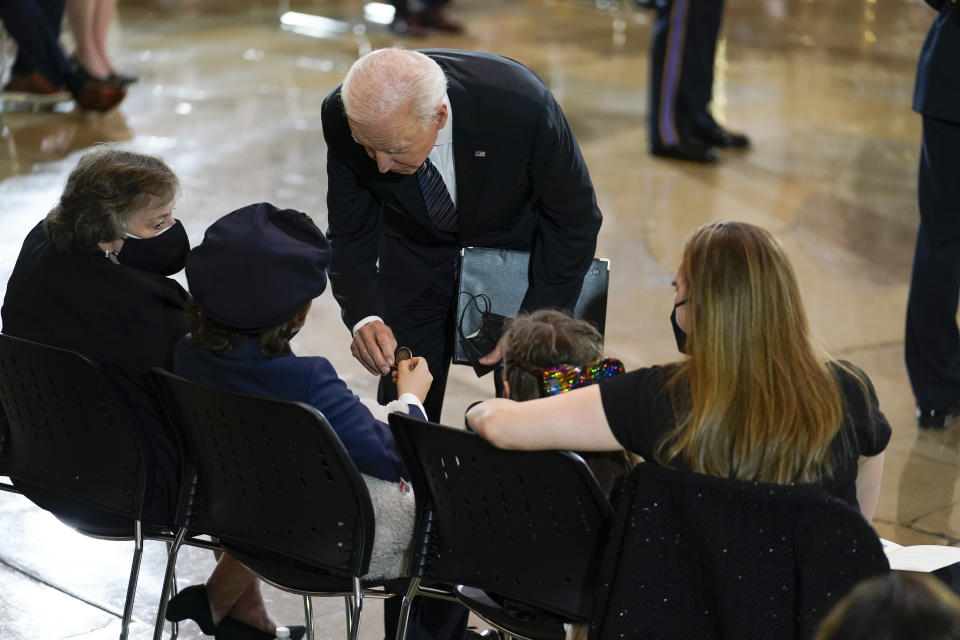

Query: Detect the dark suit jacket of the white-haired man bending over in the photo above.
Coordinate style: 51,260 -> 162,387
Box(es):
322,49 -> 601,328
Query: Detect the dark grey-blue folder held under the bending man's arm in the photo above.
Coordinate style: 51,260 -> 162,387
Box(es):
453,247 -> 610,376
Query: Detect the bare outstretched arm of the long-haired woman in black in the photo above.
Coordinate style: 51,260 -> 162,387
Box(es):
466,385 -> 623,451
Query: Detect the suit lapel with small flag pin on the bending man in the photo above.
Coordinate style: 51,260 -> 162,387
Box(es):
447,70 -> 492,238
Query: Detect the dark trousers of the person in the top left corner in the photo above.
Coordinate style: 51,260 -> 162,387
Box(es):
0,0 -> 70,87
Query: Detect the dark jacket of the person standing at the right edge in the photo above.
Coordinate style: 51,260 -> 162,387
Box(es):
913,0 -> 960,122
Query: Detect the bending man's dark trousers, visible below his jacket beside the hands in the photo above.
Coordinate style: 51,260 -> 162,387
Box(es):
377,268 -> 456,422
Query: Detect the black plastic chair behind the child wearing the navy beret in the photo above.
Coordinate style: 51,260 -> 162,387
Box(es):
151,369 -> 404,640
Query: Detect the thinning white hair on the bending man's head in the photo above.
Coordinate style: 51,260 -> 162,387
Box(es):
340,48 -> 447,127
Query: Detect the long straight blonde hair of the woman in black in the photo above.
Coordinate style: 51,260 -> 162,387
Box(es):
657,222 -> 863,484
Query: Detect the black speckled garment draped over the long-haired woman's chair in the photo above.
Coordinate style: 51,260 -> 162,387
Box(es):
591,463 -> 889,640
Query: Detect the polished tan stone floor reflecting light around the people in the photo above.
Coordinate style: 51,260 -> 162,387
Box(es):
0,0 -> 948,640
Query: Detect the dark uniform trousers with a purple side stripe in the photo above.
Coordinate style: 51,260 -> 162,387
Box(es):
649,0 -> 723,146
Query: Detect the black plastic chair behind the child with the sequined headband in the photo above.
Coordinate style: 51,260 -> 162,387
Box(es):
390,413 -> 613,640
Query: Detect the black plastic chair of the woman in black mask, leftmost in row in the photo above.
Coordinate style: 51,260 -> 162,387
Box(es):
0,335 -> 191,639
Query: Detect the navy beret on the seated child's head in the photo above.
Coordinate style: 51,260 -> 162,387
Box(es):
186,202 -> 330,334
